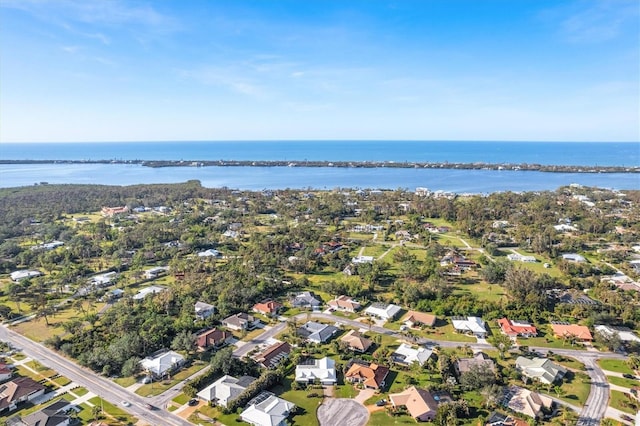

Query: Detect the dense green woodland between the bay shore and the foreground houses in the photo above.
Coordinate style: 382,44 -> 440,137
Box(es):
0,181 -> 640,390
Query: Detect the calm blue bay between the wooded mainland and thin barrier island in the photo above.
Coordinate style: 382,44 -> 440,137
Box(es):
0,164 -> 640,193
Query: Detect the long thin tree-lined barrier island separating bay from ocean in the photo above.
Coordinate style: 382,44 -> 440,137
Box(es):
0,159 -> 640,173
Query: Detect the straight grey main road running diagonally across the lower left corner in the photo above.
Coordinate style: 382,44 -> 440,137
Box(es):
0,326 -> 192,426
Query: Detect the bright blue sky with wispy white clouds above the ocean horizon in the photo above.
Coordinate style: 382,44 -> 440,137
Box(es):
0,0 -> 640,142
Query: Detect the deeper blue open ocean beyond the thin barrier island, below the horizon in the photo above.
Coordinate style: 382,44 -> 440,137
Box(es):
0,141 -> 640,166
